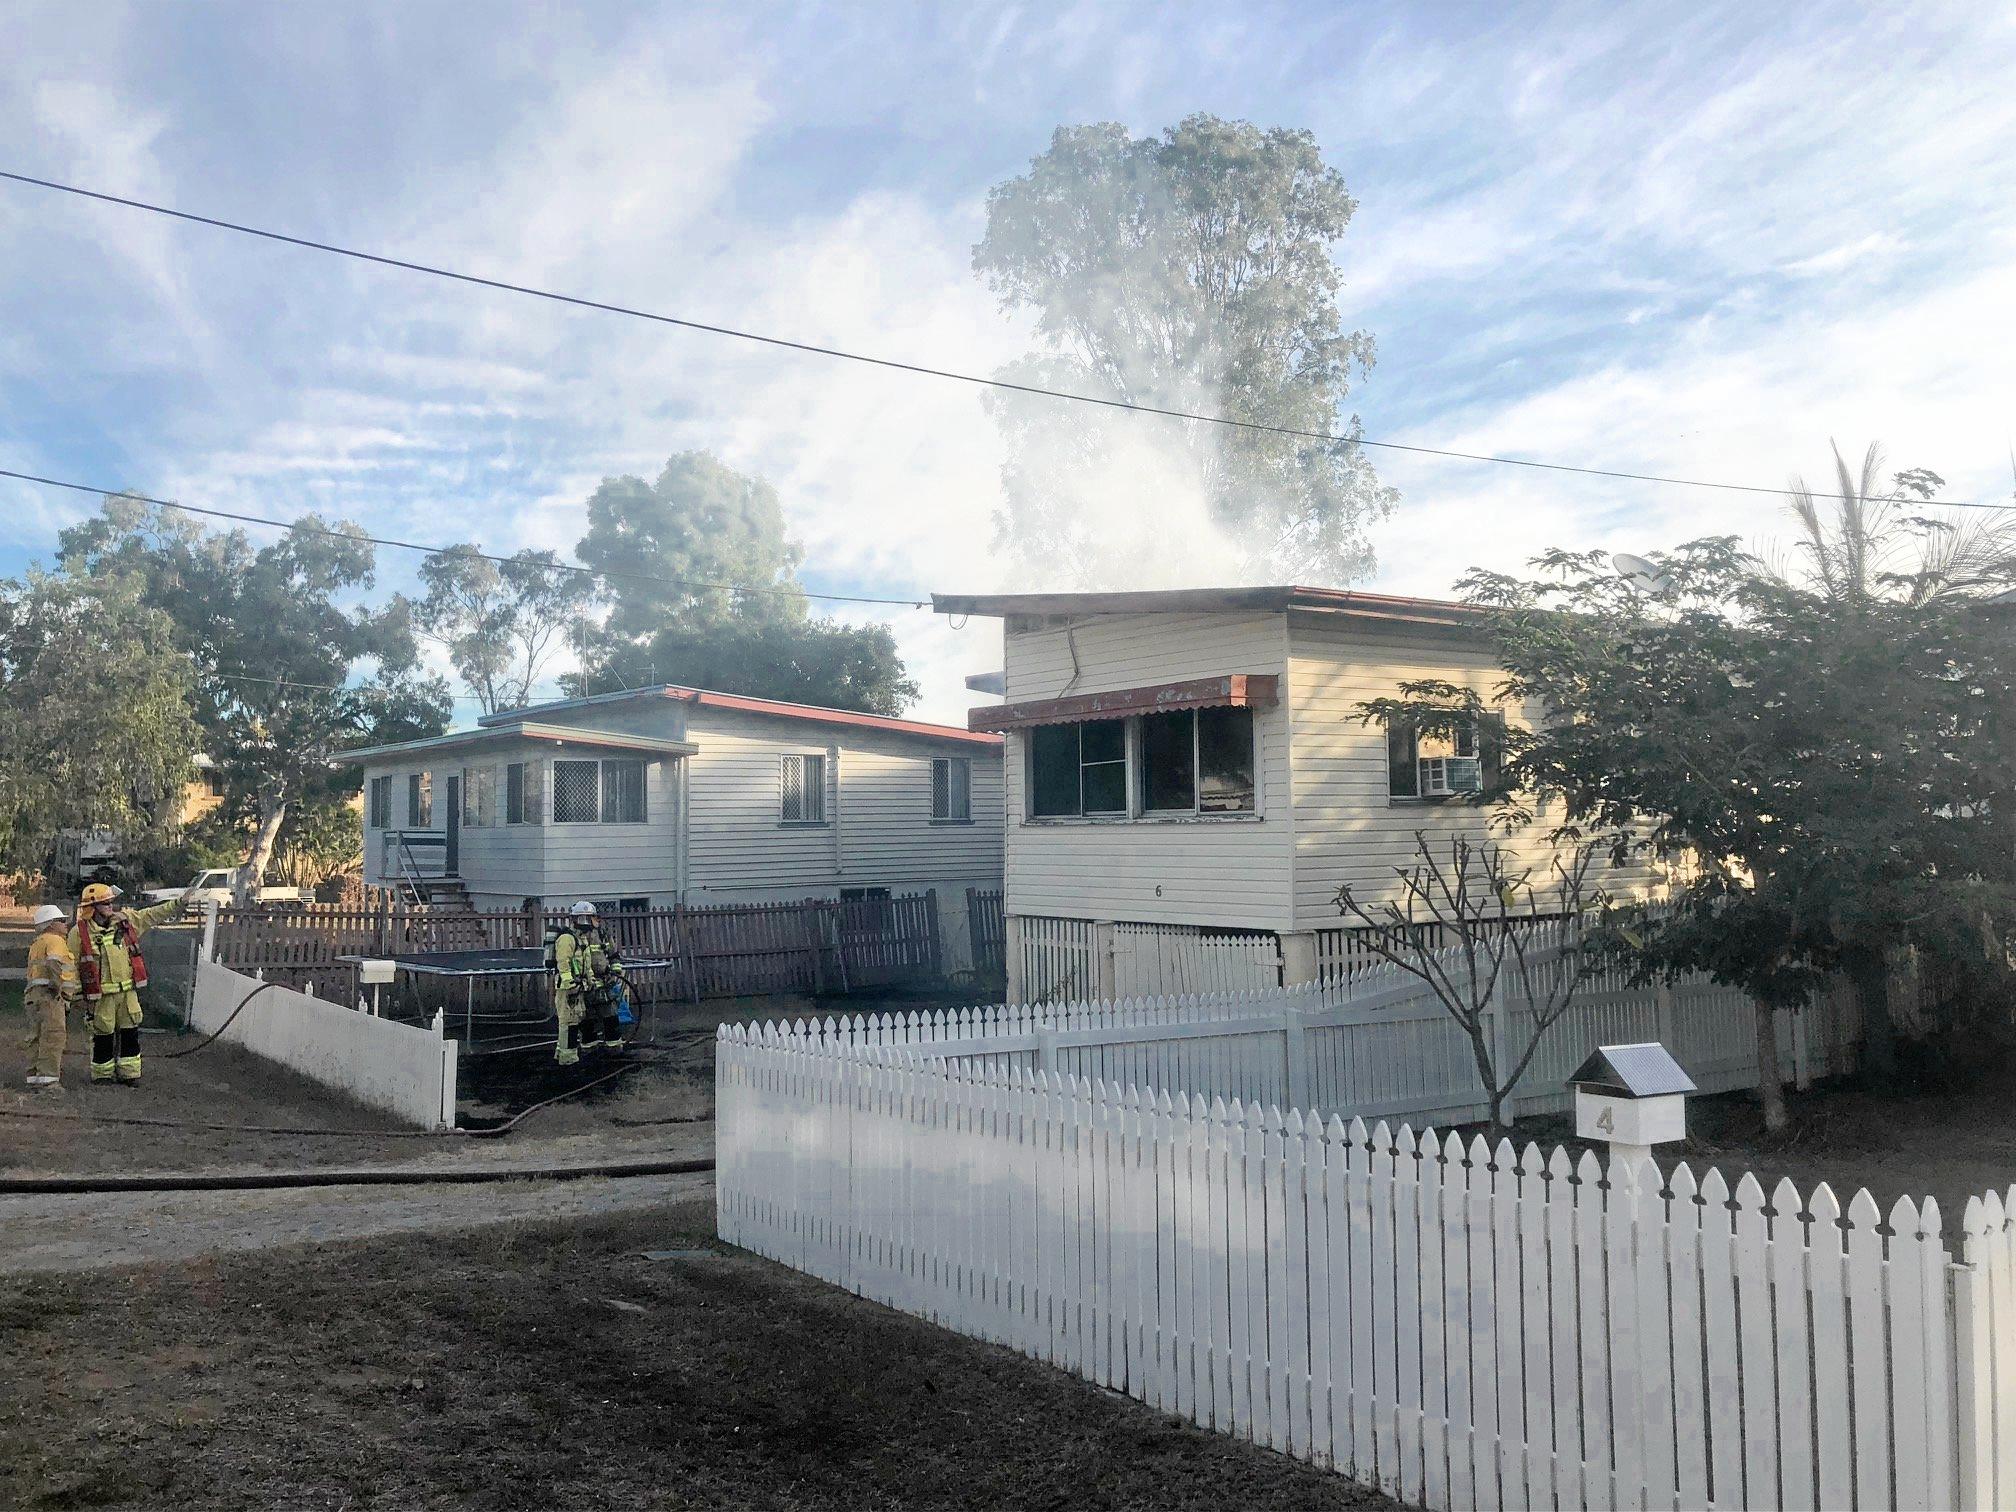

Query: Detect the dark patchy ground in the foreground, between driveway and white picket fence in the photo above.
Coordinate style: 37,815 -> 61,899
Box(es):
0,1202 -> 1391,1512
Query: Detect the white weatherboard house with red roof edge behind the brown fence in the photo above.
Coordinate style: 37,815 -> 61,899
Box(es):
349,687 -> 1002,971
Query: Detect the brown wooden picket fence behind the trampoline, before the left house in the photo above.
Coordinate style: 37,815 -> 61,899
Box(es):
214,893 -> 943,1012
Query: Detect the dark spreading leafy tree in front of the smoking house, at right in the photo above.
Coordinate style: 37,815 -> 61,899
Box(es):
1361,538 -> 2016,1127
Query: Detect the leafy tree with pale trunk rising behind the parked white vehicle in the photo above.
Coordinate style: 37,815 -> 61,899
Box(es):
58,496 -> 450,893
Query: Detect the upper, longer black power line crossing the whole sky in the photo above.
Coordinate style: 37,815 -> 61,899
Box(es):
0,169 -> 2002,512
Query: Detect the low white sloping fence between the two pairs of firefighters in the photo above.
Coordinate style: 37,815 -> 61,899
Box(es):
190,960 -> 456,1129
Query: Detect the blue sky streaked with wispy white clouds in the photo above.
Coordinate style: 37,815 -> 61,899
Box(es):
0,2 -> 2016,718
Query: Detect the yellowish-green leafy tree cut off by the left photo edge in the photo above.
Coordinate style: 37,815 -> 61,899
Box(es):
0,573 -> 198,871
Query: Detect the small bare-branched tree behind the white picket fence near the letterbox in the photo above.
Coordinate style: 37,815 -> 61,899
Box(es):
1337,831 -> 1607,1127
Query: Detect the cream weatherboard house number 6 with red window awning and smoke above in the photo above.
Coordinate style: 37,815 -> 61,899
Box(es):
933,587 -> 1643,1002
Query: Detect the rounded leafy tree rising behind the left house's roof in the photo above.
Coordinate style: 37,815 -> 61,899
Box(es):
562,452 -> 917,714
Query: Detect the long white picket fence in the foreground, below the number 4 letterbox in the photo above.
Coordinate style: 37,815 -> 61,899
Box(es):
716,1026 -> 2016,1512
